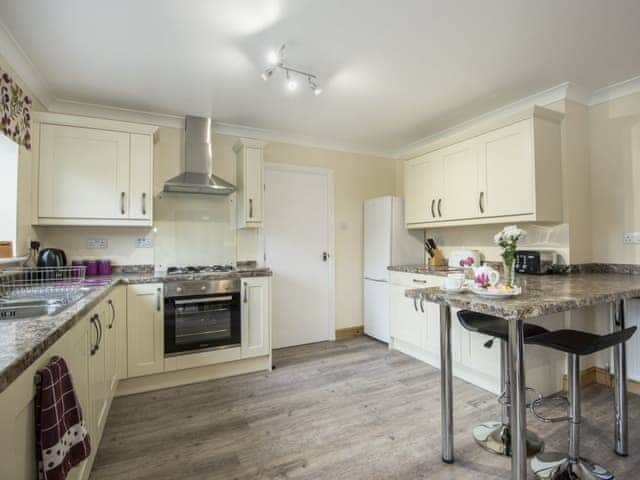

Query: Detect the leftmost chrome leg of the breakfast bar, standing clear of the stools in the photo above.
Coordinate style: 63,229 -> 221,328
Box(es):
440,305 -> 453,463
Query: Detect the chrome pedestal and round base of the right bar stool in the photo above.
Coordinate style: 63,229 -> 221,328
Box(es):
531,354 -> 615,480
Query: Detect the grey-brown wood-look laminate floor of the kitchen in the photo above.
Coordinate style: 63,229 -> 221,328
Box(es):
91,337 -> 640,480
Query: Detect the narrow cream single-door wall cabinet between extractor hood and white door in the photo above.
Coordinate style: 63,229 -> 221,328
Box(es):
233,138 -> 266,228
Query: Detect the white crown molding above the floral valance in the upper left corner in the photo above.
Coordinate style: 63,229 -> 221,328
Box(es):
0,19 -> 54,108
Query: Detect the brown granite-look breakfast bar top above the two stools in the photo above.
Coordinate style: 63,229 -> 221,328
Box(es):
405,273 -> 640,320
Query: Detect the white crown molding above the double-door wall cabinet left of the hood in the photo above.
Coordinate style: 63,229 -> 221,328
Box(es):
49,99 -> 184,128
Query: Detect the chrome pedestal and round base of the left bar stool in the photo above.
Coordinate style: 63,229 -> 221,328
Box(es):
472,340 -> 544,456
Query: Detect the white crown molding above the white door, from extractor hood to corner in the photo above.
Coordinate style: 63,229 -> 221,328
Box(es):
213,122 -> 392,158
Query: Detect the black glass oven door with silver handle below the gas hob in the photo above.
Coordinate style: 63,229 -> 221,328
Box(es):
164,293 -> 240,355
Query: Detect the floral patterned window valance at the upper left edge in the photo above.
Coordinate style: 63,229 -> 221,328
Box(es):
0,69 -> 31,150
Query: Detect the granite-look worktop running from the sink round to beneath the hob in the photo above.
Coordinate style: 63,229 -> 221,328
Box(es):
0,267 -> 272,393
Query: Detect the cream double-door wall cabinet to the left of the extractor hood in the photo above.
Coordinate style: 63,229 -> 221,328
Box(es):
33,113 -> 155,226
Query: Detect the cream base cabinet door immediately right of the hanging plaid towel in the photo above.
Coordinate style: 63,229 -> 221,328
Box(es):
89,308 -> 108,438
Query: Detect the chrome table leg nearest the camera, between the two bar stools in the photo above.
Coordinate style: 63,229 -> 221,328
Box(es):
509,320 -> 527,480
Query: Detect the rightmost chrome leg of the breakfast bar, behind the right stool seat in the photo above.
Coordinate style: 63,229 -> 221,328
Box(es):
610,300 -> 629,457
